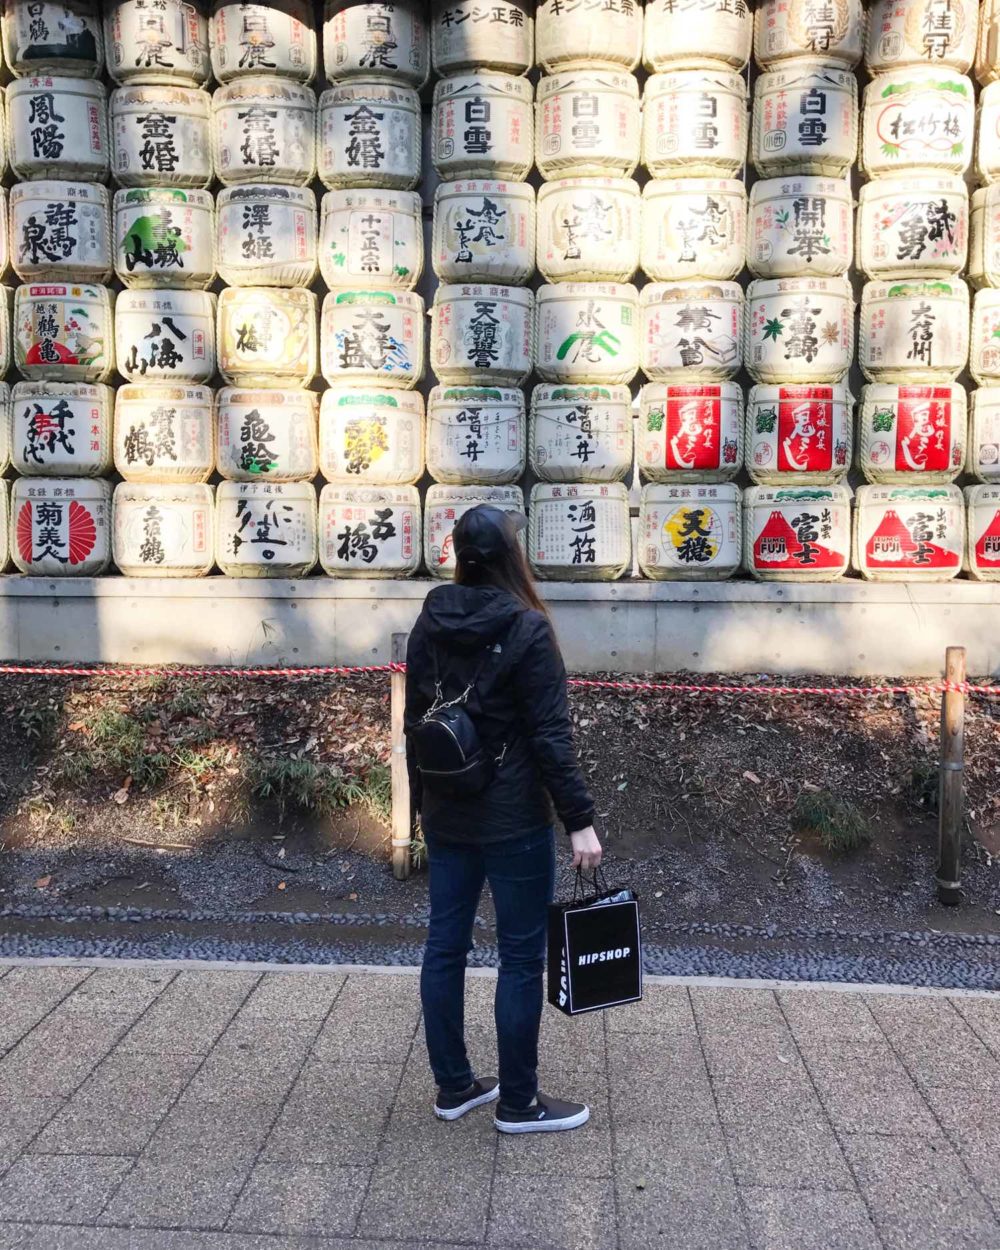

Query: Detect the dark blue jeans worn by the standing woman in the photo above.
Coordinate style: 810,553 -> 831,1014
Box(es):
420,829 -> 555,1110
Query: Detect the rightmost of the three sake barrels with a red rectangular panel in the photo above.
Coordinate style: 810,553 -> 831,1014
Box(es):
858,383 -> 968,484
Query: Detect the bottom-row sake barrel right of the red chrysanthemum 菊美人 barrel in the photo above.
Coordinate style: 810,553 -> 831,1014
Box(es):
111,481 -> 215,578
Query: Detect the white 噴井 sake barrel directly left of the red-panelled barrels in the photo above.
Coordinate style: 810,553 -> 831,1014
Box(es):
528,385 -> 633,481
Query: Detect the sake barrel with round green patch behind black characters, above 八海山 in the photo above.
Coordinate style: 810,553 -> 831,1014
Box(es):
114,186 -> 215,290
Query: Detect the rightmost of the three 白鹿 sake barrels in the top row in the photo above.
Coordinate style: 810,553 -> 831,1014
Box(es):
323,0 -> 430,88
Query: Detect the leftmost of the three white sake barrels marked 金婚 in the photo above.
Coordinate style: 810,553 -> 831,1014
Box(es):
110,86 -> 213,188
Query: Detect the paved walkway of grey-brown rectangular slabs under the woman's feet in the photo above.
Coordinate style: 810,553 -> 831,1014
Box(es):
0,965 -> 1000,1250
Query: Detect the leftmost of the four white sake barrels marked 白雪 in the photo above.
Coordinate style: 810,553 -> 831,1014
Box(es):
431,70 -> 535,183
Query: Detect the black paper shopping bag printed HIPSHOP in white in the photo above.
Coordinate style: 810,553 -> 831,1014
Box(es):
549,873 -> 643,1015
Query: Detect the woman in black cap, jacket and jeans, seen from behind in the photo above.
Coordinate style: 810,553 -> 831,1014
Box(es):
406,505 -> 601,1133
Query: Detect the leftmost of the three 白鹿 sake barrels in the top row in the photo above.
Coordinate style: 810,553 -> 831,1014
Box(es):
104,0 -> 211,86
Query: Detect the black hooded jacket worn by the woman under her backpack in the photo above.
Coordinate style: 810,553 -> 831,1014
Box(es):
405,584 -> 594,844
